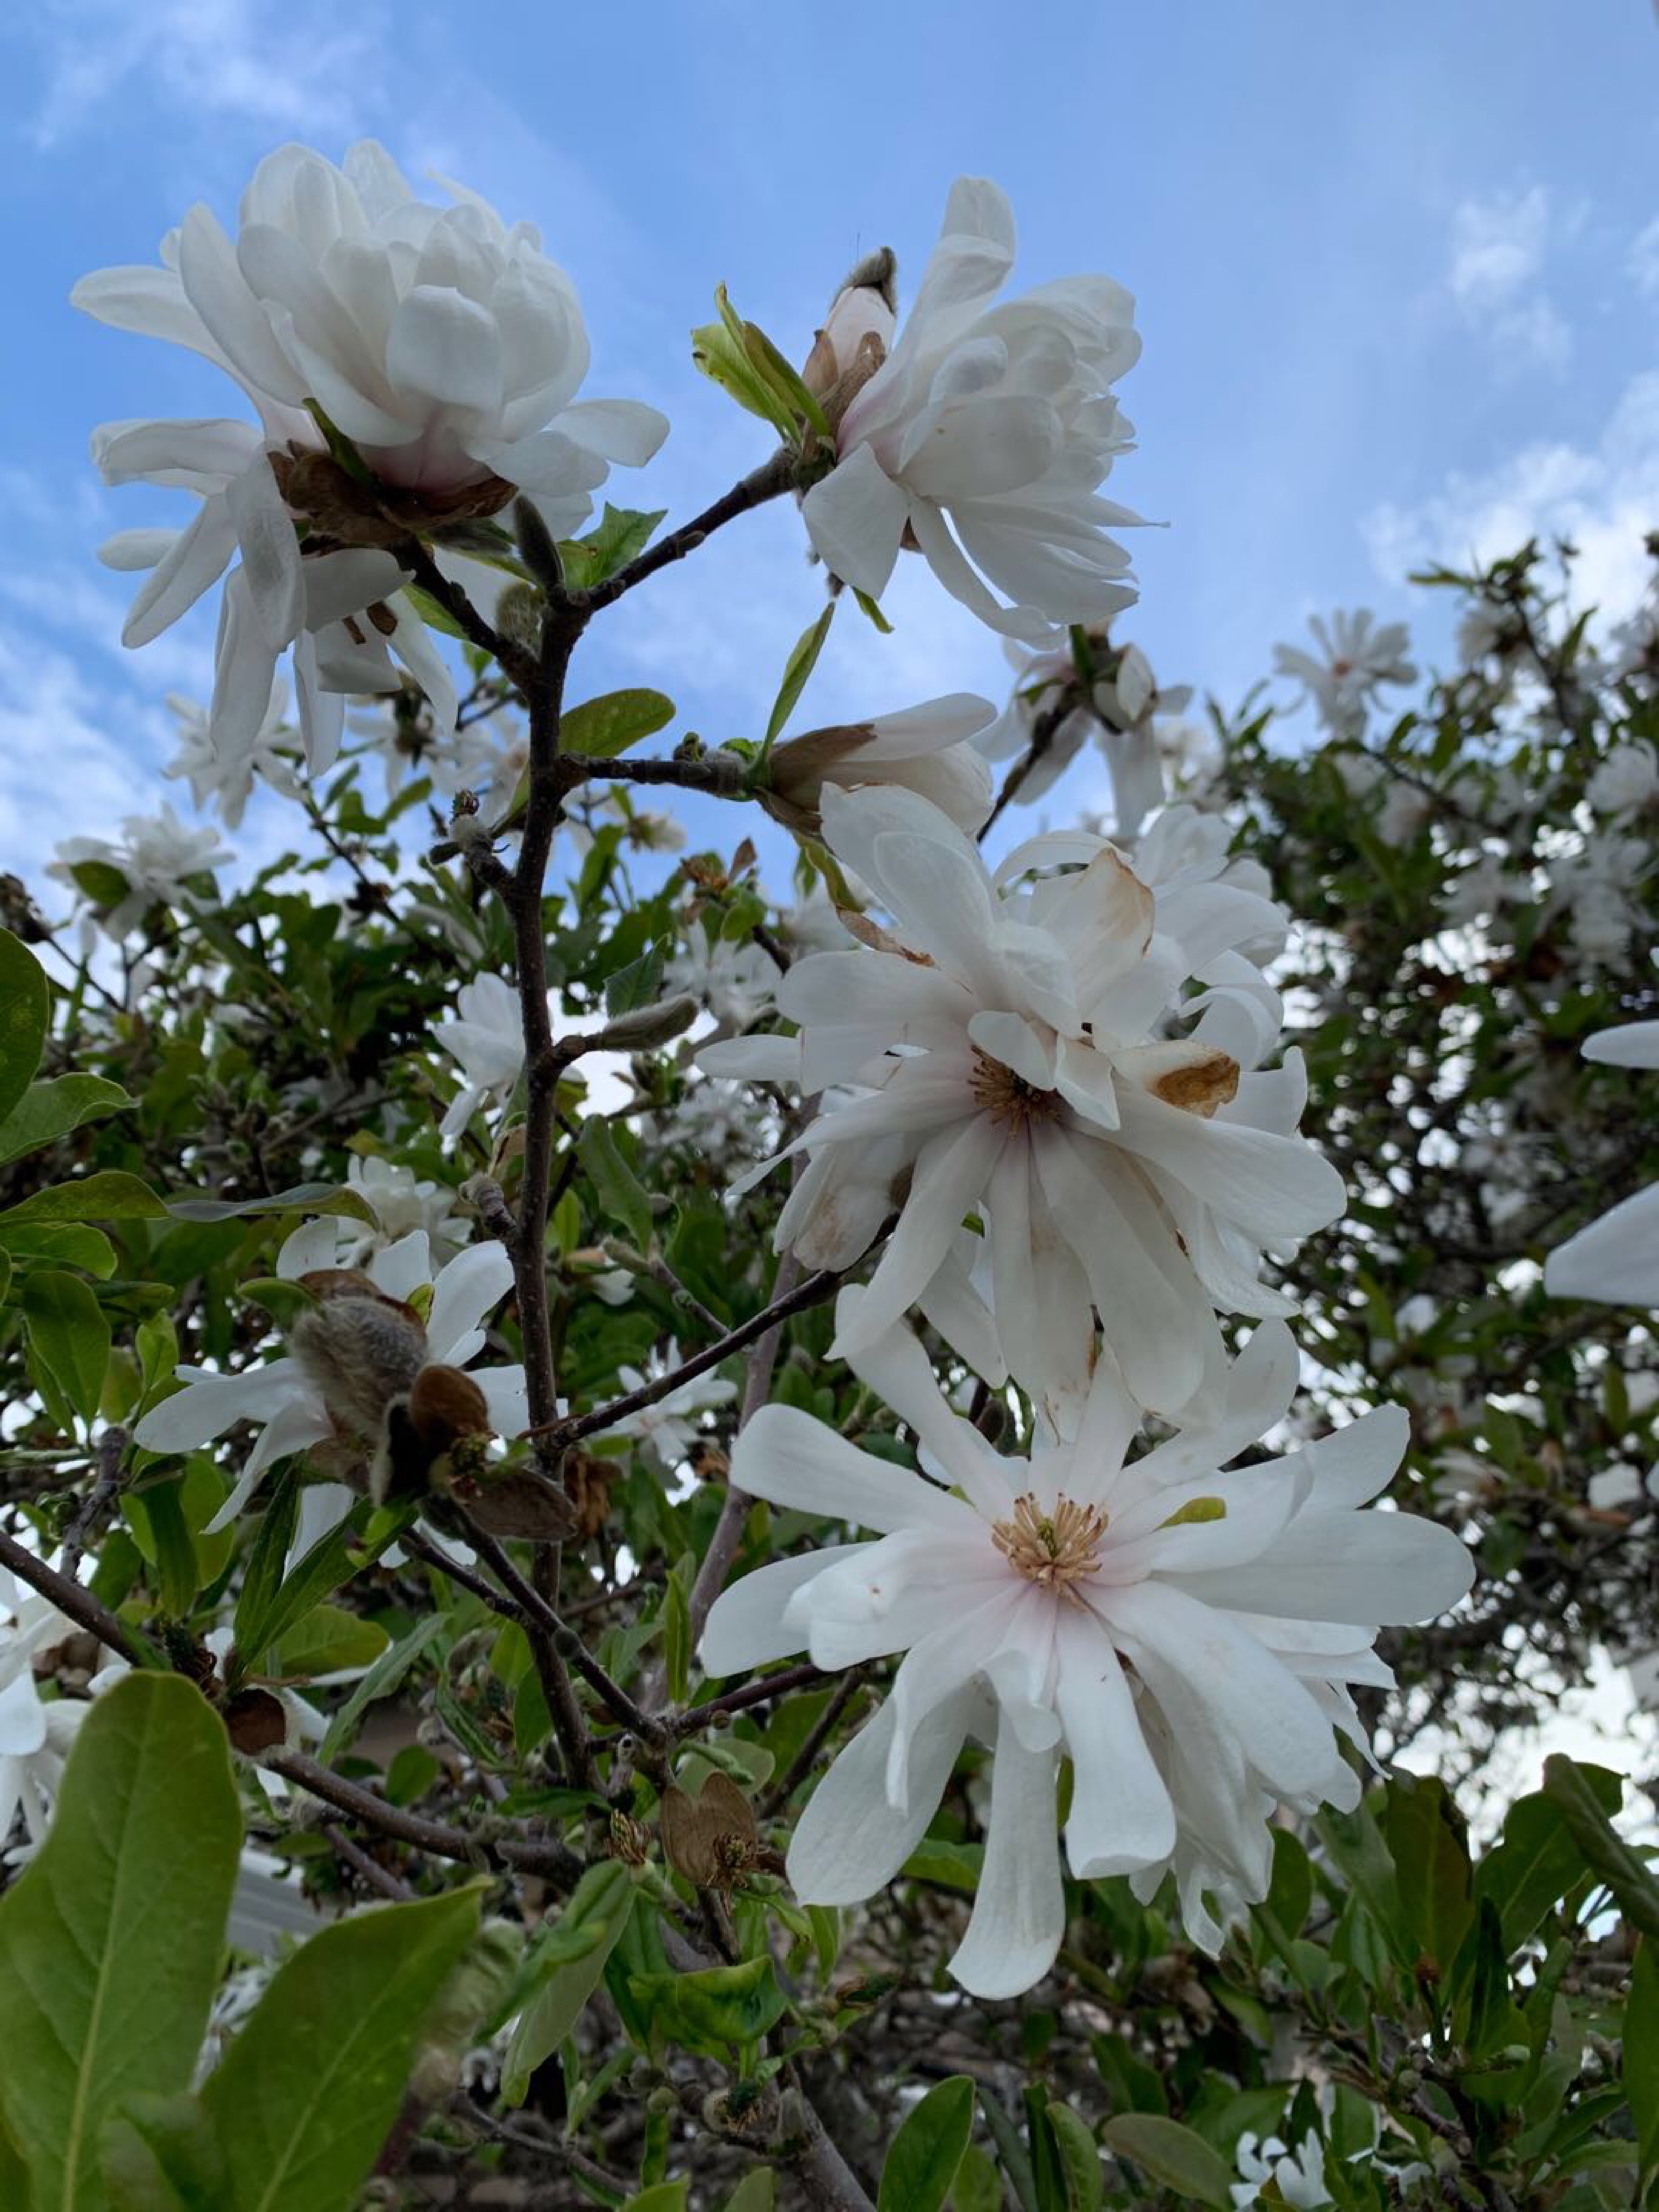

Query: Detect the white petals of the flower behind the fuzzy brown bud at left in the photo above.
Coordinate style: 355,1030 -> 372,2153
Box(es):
133,1217 -> 528,1533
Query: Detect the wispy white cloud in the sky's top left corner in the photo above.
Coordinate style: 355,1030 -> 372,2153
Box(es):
31,0 -> 389,148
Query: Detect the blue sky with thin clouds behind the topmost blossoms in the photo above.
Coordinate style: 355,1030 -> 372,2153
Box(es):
0,0 -> 1659,883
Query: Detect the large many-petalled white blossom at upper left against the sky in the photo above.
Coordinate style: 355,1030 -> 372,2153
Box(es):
71,141 -> 668,768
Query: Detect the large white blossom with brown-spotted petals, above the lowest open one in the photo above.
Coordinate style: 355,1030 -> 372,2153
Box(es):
699,790 -> 1343,1413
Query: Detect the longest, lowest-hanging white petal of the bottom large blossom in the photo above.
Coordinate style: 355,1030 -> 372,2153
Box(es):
949,1728 -> 1066,1997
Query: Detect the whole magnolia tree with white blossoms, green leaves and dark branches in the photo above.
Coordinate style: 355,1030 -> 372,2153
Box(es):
0,146 -> 1659,2212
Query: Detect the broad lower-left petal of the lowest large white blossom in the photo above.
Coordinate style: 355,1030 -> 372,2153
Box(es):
788,1690 -> 977,1905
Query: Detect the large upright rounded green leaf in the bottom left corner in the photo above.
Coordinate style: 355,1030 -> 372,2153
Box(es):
0,1674 -> 241,2212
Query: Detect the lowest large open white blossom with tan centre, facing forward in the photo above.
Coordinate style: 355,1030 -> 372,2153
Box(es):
701,1290 -> 1473,1997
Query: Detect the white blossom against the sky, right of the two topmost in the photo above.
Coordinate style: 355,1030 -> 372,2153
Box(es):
803,177 -> 1139,642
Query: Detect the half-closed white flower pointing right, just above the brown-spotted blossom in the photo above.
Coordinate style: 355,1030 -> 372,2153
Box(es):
759,692 -> 997,836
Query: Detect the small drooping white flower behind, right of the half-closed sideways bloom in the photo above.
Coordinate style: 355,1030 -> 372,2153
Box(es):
980,630 -> 1192,838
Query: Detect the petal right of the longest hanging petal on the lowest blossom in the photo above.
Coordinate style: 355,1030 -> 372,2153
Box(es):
1055,1606 -> 1175,1882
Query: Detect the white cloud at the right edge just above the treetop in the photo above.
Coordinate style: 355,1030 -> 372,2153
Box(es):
1360,369 -> 1659,622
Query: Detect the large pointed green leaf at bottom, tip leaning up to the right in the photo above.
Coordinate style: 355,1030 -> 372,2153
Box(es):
201,1889 -> 480,2212
